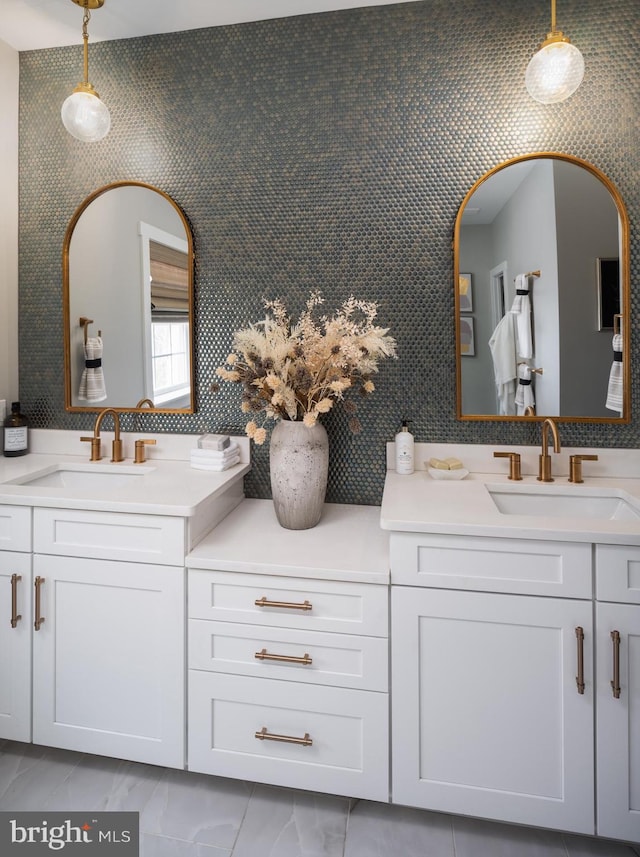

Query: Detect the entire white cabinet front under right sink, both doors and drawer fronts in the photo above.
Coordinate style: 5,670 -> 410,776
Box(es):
391,533 -> 640,841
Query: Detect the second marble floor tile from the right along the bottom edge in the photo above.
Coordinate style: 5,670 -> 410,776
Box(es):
452,816 -> 567,857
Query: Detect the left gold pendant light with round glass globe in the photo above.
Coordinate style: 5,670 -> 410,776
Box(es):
60,0 -> 111,143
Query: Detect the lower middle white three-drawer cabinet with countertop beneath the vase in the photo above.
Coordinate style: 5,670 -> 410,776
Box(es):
182,500 -> 389,801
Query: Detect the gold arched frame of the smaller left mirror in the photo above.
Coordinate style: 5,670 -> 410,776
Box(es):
62,180 -> 195,414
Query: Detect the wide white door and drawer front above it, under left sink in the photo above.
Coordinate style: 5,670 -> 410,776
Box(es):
32,508 -> 186,767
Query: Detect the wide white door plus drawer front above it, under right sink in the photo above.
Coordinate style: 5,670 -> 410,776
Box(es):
391,533 -> 594,833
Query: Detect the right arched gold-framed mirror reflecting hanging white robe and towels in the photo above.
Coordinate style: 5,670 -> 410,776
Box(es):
454,153 -> 631,422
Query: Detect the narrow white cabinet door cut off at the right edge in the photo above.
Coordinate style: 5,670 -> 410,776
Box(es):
596,604 -> 640,842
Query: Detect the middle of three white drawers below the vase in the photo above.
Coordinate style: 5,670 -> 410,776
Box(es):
189,619 -> 389,691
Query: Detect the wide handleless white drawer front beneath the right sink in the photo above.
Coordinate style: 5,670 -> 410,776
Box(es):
391,533 -> 592,598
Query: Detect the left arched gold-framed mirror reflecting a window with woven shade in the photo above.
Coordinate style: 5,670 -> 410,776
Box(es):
62,182 -> 194,413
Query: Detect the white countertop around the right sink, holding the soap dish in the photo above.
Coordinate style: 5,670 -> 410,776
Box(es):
380,464 -> 640,545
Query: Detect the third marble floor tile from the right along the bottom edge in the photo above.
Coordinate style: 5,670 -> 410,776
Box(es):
344,801 -> 454,857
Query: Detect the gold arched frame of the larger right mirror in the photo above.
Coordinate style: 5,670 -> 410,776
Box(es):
453,152 -> 631,424
